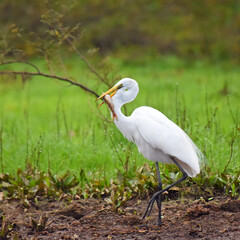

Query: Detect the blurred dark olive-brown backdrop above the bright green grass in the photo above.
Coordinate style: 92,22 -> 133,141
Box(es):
0,0 -> 240,62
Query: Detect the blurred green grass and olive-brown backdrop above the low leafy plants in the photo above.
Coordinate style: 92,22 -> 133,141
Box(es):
0,0 -> 240,192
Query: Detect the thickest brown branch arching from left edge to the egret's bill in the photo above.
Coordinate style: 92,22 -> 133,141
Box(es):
0,71 -> 99,97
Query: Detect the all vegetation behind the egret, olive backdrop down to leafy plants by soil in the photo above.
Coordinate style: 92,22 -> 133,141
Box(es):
0,1 -> 240,212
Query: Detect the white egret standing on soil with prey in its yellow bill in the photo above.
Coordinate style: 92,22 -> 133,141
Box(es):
96,78 -> 204,225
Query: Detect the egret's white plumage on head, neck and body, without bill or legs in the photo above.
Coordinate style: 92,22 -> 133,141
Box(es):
101,78 -> 201,177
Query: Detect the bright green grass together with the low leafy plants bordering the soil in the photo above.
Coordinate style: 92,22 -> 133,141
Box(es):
1,57 -> 240,206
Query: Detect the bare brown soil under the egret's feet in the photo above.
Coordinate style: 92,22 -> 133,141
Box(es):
0,197 -> 240,240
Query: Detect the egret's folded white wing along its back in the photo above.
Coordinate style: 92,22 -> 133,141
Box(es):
132,107 -> 202,175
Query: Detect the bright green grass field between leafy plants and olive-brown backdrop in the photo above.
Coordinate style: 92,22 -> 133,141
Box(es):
0,57 -> 240,184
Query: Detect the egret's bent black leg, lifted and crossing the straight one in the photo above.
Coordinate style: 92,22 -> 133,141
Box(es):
142,156 -> 188,222
